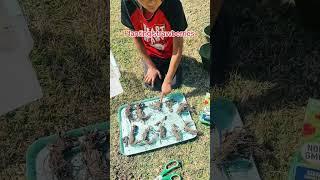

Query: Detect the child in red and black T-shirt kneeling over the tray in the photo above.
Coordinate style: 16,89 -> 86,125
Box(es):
121,0 -> 188,96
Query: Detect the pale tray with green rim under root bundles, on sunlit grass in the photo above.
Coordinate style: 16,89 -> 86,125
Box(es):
118,93 -> 197,156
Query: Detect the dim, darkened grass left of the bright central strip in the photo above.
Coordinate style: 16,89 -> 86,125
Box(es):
0,0 -> 108,179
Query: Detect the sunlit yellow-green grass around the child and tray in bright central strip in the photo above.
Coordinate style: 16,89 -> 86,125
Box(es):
110,0 -> 210,179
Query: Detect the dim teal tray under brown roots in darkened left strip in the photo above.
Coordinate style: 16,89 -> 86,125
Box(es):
26,122 -> 108,180
